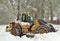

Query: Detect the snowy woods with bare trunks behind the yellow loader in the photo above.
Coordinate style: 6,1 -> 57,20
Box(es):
0,0 -> 60,24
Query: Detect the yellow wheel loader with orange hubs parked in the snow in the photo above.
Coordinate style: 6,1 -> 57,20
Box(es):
6,14 -> 56,37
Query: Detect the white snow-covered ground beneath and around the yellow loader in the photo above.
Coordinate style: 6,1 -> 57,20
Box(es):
0,25 -> 60,41
